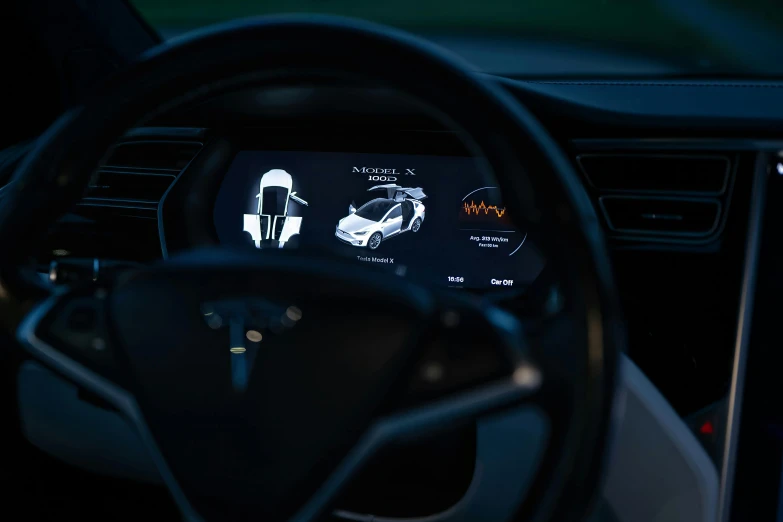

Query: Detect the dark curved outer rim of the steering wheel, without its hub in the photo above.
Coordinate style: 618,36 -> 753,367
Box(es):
0,17 -> 623,520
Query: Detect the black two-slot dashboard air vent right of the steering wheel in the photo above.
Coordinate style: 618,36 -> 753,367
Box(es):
574,146 -> 740,244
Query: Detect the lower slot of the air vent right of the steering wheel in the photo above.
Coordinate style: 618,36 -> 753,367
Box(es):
599,196 -> 721,237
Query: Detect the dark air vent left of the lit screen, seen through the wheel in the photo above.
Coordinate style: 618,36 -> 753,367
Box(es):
44,127 -> 206,266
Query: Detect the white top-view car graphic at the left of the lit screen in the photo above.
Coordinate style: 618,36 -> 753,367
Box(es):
244,169 -> 307,248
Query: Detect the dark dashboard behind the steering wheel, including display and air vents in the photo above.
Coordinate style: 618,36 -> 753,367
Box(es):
18,72 -> 783,511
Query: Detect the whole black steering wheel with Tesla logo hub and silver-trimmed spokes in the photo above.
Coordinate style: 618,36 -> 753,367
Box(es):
0,17 -> 623,521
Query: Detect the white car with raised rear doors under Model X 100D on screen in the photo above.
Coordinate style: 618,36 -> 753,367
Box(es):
334,185 -> 427,250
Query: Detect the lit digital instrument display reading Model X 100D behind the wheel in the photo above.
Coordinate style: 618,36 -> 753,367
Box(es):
213,150 -> 544,289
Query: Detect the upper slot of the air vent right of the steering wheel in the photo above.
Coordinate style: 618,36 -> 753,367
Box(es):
577,154 -> 731,196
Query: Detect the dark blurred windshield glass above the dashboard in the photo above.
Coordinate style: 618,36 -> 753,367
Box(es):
132,0 -> 783,77
